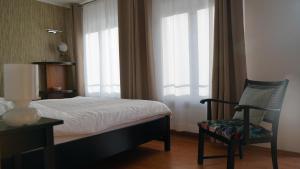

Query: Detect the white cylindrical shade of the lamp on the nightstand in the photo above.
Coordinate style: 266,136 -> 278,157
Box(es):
4,64 -> 38,101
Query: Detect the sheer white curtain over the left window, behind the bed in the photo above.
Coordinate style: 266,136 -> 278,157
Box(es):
83,0 -> 120,97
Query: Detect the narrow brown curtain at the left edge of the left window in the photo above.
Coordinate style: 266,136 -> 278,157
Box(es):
71,4 -> 85,96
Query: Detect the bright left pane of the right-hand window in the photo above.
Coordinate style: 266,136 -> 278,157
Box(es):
162,13 -> 190,96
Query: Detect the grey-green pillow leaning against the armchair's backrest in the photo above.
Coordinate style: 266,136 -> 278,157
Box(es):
233,86 -> 272,125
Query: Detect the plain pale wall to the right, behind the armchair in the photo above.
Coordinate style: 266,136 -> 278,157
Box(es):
244,0 -> 300,152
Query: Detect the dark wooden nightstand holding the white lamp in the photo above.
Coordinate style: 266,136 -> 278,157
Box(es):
0,118 -> 63,169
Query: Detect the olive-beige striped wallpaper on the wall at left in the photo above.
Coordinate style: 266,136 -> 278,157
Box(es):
0,0 -> 70,96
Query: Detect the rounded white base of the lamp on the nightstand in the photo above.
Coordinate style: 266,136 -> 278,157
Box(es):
2,108 -> 41,127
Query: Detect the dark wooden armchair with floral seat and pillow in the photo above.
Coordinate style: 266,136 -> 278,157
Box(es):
198,80 -> 289,169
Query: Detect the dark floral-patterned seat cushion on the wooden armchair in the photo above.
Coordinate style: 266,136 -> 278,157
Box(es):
199,119 -> 272,140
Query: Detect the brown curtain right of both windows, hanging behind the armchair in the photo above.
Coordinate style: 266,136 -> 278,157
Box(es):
212,0 -> 247,119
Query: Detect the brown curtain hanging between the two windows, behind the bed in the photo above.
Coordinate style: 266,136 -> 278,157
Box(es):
118,0 -> 154,99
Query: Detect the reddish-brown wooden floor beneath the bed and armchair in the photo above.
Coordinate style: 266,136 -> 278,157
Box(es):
86,134 -> 300,169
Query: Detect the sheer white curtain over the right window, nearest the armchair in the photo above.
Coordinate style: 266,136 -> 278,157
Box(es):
152,0 -> 213,132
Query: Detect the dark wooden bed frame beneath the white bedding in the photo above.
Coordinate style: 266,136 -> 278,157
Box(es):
23,116 -> 170,169
